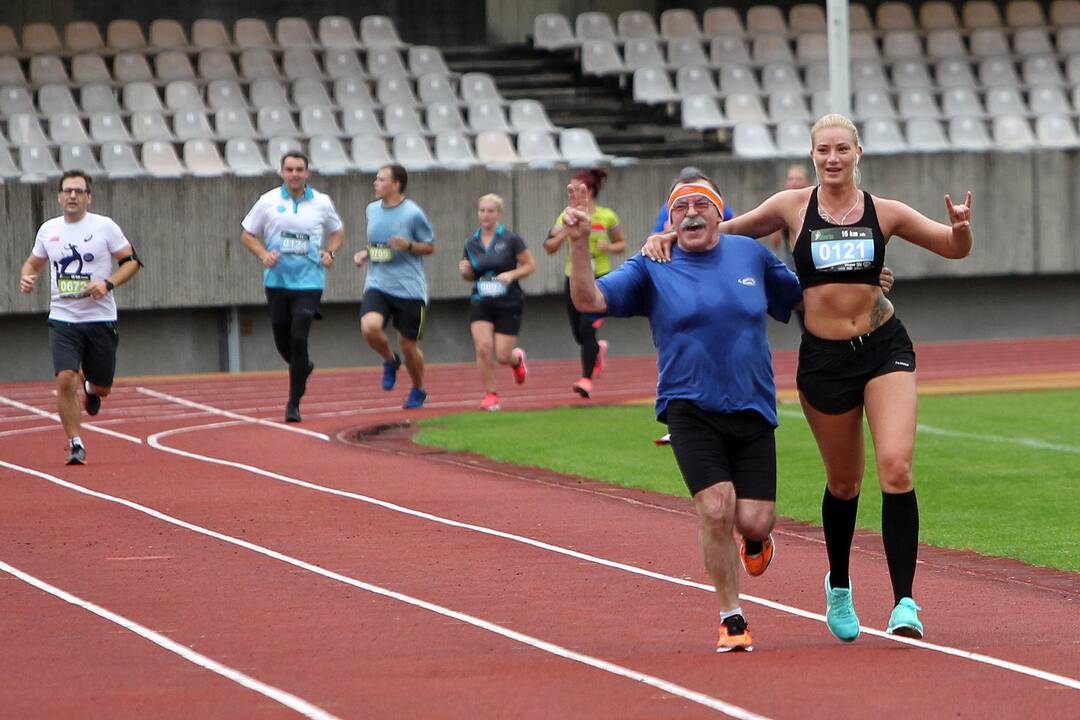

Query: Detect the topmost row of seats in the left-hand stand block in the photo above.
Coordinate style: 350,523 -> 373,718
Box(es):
0,15 -> 406,55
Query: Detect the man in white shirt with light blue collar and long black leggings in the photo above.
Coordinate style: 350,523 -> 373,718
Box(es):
240,152 -> 345,422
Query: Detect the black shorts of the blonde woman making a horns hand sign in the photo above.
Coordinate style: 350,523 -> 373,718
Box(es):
796,315 -> 915,415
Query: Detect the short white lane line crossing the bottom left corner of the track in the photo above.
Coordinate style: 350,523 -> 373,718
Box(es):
0,557 -> 336,720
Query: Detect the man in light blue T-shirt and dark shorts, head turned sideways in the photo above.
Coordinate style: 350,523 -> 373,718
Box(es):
353,165 -> 435,409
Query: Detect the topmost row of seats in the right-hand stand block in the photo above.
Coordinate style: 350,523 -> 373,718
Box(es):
532,0 -> 1080,50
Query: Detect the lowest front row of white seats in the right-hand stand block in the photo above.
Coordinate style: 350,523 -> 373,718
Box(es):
732,116 -> 1080,158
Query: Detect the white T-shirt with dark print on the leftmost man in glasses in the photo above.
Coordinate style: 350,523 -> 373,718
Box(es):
33,213 -> 131,323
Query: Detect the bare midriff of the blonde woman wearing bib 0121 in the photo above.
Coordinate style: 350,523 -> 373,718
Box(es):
802,283 -> 893,340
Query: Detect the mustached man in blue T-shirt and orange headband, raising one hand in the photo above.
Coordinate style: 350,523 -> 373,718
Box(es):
565,178 -> 801,652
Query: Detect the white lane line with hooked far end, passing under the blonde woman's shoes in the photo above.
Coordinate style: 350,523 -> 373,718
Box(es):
147,423 -> 1080,690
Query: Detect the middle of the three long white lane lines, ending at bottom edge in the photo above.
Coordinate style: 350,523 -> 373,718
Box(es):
0,460 -> 768,720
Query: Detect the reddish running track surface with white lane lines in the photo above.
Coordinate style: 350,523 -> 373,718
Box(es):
0,338 -> 1080,719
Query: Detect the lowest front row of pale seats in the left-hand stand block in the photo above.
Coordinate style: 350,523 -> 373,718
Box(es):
0,128 -> 612,182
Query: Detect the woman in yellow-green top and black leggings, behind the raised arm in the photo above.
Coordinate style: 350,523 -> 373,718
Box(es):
543,167 -> 626,397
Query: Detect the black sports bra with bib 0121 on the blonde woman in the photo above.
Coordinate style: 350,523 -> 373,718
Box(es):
792,188 -> 885,288
